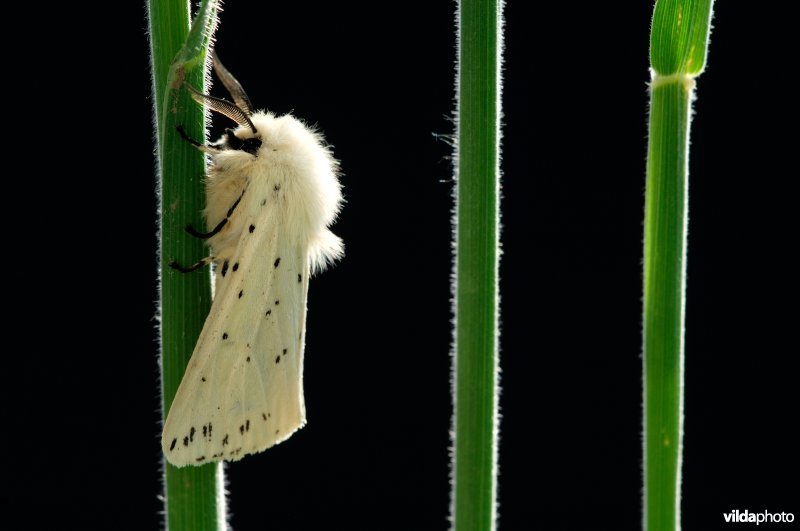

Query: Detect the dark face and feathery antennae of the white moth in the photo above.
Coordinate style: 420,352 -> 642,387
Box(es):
187,52 -> 261,155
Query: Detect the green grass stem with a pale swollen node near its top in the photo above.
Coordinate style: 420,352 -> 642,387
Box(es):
643,0 -> 712,531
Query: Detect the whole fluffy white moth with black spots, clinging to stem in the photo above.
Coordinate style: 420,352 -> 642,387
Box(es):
161,56 -> 343,466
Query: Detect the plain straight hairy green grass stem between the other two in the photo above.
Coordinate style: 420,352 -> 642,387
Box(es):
451,0 -> 502,531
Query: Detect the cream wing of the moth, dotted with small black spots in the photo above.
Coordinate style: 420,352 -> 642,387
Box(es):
161,182 -> 309,466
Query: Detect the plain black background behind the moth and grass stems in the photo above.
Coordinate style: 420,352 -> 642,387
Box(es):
9,0 -> 800,531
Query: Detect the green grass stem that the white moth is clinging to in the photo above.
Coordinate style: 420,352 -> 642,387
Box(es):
148,0 -> 226,531
